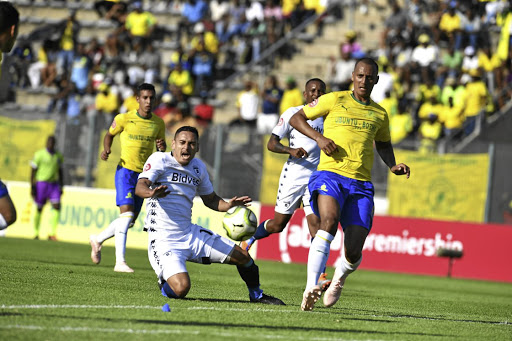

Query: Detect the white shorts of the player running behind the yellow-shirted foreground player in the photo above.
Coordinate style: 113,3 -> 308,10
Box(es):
274,175 -> 313,216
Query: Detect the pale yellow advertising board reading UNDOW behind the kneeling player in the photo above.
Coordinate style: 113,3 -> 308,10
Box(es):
4,182 -> 253,249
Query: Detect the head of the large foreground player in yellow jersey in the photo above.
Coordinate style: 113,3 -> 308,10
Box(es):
352,57 -> 379,102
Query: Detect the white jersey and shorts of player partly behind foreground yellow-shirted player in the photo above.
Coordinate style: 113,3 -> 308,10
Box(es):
272,105 -> 324,215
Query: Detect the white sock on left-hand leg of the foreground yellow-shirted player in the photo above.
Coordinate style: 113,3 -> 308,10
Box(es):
306,230 -> 334,290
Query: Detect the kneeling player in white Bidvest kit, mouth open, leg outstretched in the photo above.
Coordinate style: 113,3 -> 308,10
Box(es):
135,126 -> 284,305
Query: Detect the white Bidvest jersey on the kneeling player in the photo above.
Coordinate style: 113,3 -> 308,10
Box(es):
139,152 -> 213,238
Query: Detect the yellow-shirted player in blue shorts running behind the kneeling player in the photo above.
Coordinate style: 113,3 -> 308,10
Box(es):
89,83 -> 167,272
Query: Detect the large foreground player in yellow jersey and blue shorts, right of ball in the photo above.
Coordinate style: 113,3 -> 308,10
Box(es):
290,58 -> 410,310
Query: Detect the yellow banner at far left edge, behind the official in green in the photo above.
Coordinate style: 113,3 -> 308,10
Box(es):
0,117 -> 55,181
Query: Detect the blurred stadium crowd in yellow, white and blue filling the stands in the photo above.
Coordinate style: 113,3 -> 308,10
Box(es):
4,0 -> 512,152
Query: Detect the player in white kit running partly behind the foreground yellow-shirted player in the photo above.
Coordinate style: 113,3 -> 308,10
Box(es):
241,78 -> 330,289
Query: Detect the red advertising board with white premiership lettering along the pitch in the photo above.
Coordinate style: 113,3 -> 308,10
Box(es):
253,206 -> 512,282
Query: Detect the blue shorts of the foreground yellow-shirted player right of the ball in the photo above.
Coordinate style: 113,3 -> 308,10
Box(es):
308,171 -> 374,231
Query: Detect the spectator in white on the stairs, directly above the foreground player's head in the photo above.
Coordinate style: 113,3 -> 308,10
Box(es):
326,44 -> 356,91
